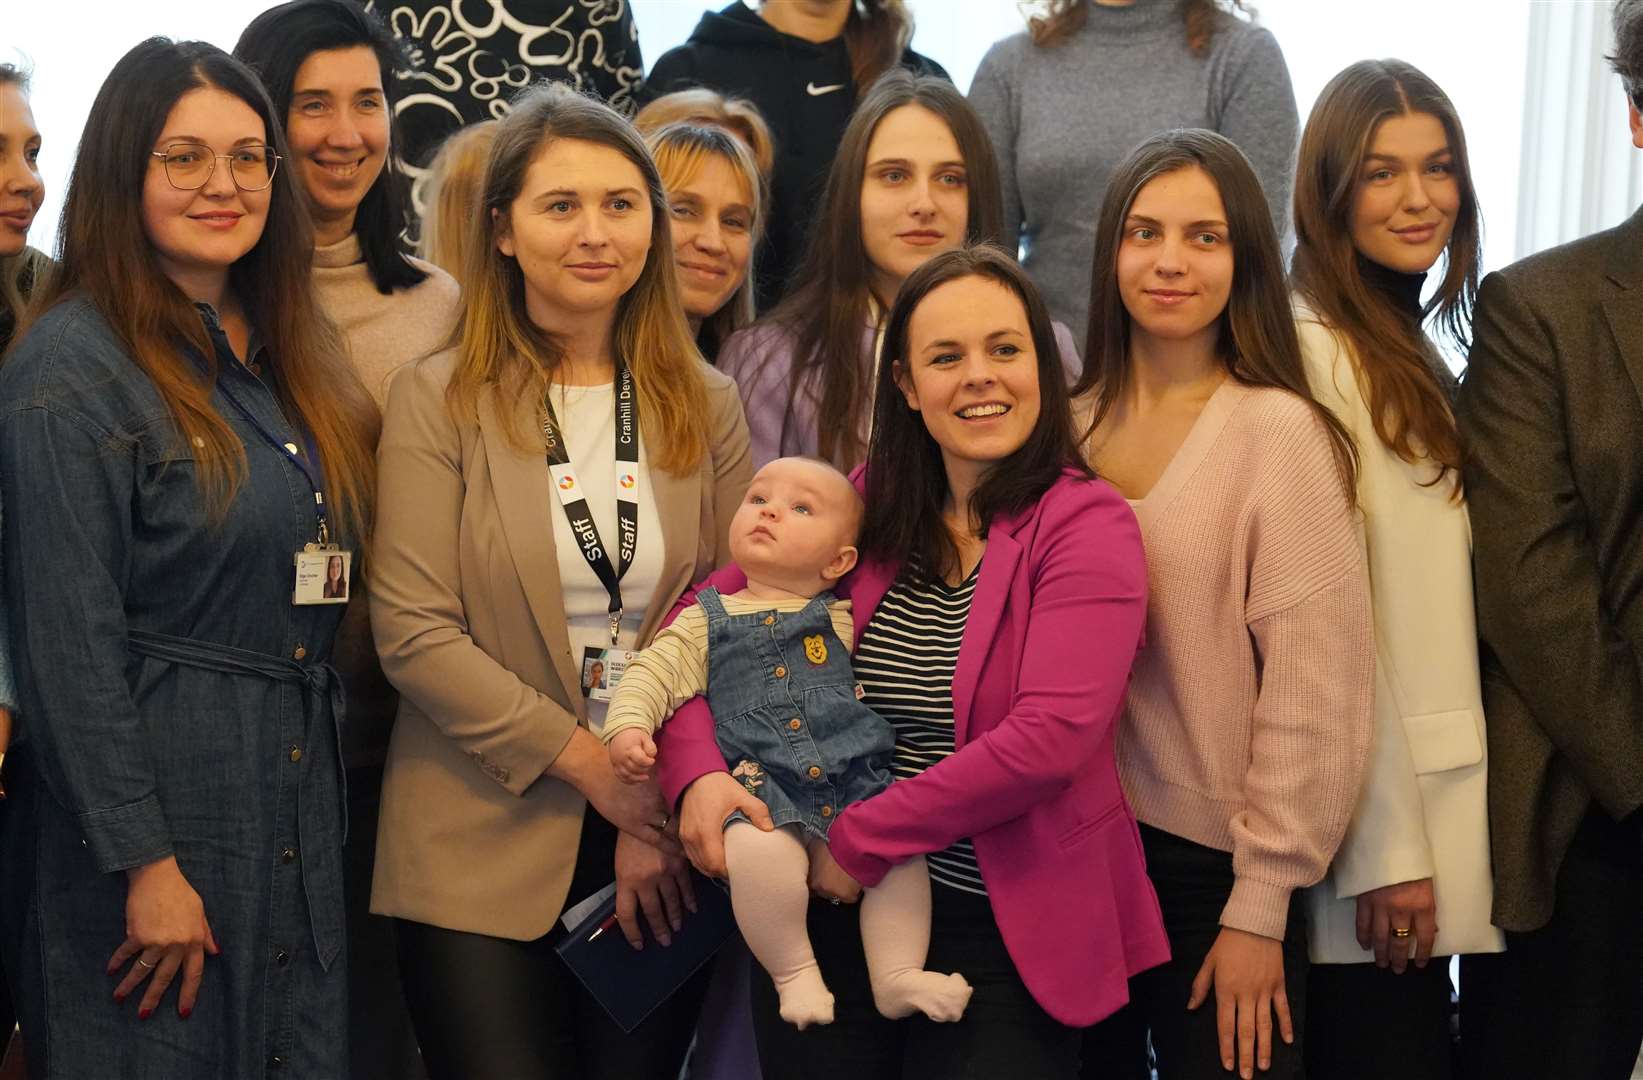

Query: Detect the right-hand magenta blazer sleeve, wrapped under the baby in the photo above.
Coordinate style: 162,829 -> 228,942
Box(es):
828,480 -> 1147,886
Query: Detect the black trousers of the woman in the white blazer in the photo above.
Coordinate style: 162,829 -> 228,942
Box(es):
1306,957 -> 1456,1080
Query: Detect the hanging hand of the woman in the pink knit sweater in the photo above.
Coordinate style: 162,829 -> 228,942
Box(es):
1186,927 -> 1295,1080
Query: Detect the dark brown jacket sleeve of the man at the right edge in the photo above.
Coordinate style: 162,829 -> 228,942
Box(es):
1459,264 -> 1643,819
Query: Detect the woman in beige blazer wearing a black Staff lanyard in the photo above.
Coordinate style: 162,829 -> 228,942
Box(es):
371,87 -> 751,1080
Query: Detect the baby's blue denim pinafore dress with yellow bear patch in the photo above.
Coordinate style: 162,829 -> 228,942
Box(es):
697,588 -> 895,840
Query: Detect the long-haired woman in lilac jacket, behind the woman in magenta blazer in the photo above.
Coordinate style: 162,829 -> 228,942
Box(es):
718,71 -> 1078,468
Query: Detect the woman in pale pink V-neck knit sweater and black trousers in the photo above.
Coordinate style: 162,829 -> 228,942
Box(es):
1076,130 -> 1375,1080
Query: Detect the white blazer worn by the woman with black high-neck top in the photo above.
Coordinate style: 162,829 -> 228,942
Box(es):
1296,304 -> 1505,963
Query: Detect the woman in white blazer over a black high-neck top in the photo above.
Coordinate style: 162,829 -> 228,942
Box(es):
1295,61 -> 1502,1080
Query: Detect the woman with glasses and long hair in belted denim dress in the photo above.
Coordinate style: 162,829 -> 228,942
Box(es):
0,38 -> 378,1080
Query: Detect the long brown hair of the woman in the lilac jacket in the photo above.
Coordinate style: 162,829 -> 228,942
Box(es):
767,69 -> 1004,468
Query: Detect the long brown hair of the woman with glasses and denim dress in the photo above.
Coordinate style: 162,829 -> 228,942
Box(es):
22,38 -> 381,541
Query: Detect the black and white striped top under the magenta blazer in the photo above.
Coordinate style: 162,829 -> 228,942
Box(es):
853,562 -> 987,896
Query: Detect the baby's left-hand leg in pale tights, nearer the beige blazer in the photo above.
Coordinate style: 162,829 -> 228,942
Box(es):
725,822 -> 841,1031
